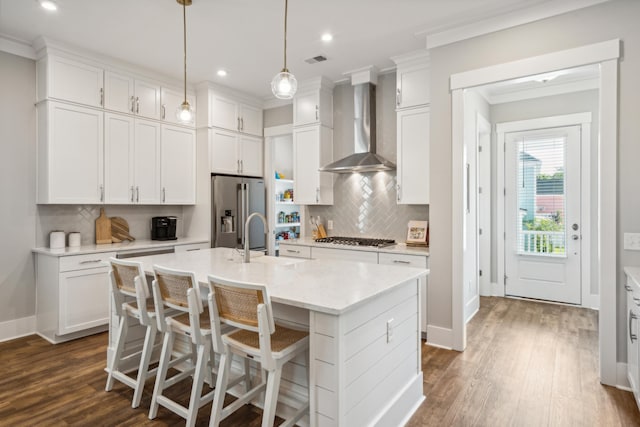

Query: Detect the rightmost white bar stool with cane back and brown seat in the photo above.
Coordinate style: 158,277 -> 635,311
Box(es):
208,275 -> 309,427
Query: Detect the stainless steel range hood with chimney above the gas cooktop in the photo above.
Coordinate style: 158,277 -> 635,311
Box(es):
320,83 -> 396,173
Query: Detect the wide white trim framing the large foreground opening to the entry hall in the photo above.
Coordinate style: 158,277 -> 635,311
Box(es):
450,39 -> 621,386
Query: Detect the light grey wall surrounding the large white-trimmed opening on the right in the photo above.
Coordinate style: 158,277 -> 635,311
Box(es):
429,0 -> 640,360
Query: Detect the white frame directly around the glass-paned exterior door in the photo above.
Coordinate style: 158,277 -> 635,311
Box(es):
496,112 -> 599,308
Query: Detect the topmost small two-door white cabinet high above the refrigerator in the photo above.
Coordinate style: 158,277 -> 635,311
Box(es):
209,92 -> 262,136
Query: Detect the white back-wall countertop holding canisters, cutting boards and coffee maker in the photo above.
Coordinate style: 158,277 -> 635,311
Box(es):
32,237 -> 209,257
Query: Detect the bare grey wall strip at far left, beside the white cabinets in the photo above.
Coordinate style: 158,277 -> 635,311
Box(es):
0,52 -> 36,324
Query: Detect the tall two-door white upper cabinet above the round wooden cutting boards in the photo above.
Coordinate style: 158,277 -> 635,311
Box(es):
105,113 -> 160,204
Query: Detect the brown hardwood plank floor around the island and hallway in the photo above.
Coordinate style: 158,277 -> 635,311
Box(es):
0,298 -> 640,427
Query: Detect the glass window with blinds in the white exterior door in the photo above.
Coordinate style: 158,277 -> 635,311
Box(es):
513,134 -> 567,257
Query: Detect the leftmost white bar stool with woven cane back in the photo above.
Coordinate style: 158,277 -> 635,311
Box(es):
105,258 -> 157,408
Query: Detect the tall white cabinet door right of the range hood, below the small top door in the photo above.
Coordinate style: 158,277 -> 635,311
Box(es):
397,107 -> 430,205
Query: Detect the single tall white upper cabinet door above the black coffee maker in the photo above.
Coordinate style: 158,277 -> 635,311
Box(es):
160,125 -> 196,205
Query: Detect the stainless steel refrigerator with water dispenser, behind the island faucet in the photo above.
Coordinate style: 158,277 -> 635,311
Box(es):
211,175 -> 267,250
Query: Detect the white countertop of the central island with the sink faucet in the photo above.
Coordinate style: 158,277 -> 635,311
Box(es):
129,248 -> 429,315
